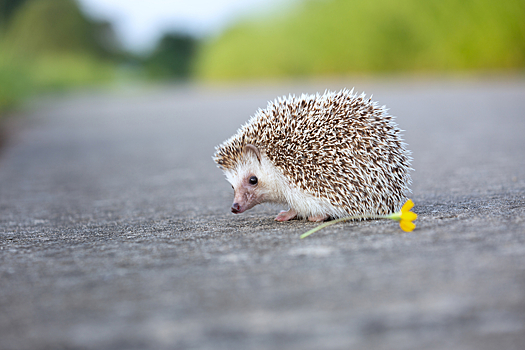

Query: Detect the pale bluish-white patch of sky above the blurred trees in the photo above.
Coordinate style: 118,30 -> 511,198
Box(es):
74,0 -> 282,52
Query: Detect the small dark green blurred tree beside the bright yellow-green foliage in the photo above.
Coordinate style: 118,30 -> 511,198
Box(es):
145,33 -> 196,79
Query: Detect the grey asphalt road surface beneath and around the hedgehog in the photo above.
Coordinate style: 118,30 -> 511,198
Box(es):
0,78 -> 525,349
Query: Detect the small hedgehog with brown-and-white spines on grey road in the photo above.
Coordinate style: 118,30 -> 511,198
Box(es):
213,89 -> 413,222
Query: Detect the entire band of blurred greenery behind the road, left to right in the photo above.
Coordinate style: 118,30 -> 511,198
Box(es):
0,0 -> 525,114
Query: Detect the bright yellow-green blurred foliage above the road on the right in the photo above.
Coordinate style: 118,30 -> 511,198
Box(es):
196,0 -> 525,79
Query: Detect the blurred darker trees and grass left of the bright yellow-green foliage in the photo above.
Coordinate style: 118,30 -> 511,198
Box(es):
0,0 -> 197,114
